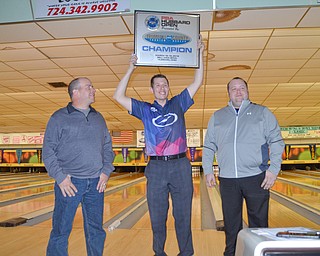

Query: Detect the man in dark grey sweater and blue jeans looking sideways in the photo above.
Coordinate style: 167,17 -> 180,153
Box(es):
42,77 -> 114,256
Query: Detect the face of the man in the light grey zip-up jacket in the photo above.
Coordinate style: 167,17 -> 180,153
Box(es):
228,79 -> 249,108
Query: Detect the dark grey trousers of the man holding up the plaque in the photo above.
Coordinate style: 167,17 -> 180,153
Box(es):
145,157 -> 193,256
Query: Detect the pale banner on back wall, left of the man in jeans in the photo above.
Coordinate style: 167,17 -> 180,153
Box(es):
0,133 -> 44,145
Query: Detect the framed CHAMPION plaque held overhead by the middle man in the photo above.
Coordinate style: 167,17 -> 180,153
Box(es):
134,11 -> 200,68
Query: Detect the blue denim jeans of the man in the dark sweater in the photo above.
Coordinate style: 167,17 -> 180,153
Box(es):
47,177 -> 106,256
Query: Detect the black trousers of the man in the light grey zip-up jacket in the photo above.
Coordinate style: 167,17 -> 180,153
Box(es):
219,172 -> 270,256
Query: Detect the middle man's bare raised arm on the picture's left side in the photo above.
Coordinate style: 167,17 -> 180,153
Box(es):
113,54 -> 137,112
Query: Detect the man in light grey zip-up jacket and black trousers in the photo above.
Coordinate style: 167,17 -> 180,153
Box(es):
202,77 -> 284,256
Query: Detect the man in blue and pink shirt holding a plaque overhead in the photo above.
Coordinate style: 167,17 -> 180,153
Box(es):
113,39 -> 204,256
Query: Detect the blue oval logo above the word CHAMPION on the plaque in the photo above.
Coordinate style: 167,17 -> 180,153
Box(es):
143,32 -> 191,45
